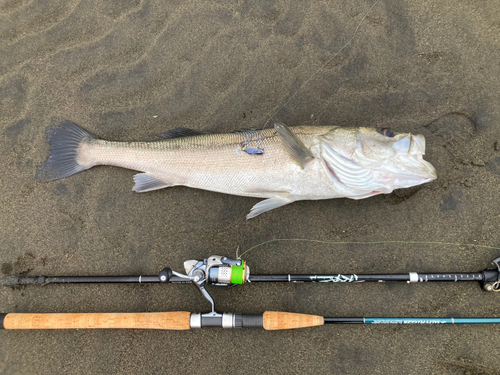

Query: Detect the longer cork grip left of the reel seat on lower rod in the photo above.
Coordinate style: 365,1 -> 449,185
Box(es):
3,311 -> 191,330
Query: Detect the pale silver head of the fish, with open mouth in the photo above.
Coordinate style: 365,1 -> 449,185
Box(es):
321,127 -> 437,196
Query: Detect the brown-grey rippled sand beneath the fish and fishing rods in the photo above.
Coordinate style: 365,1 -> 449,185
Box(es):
0,0 -> 500,374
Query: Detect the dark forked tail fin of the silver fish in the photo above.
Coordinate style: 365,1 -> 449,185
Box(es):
35,120 -> 99,182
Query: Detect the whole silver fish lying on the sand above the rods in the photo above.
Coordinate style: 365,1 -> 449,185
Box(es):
35,120 -> 437,219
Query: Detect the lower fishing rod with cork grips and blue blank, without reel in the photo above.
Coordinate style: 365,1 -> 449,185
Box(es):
0,311 -> 500,331
